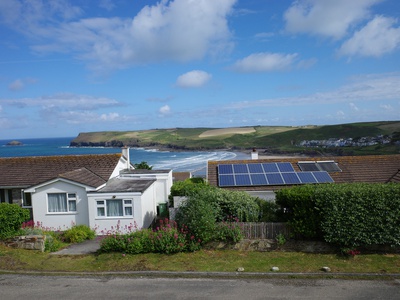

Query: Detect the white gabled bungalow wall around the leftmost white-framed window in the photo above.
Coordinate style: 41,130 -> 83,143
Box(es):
32,181 -> 89,230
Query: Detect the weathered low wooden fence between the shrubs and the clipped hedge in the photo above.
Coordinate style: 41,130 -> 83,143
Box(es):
239,222 -> 290,240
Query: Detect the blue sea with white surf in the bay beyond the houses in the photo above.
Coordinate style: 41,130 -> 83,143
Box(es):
0,137 -> 250,176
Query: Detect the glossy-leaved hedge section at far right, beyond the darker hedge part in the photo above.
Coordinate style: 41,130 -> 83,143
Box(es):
315,184 -> 400,249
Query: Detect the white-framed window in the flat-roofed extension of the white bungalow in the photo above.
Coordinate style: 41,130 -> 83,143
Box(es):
96,199 -> 133,217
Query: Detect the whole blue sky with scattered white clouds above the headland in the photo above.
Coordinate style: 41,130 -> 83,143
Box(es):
0,0 -> 400,139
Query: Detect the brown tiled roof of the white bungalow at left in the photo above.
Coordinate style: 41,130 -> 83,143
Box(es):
0,154 -> 121,188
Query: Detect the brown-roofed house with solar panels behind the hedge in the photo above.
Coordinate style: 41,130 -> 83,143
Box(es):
207,155 -> 400,200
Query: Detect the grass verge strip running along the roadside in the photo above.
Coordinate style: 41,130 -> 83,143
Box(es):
0,245 -> 400,274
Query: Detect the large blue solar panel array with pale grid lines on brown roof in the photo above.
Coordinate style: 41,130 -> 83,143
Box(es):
218,162 -> 333,187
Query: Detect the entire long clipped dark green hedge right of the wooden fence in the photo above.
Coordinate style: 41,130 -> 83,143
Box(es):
277,183 -> 400,247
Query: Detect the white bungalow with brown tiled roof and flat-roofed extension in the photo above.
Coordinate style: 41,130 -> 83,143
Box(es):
0,149 -> 172,234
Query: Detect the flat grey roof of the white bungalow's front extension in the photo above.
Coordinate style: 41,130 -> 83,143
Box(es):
96,177 -> 156,193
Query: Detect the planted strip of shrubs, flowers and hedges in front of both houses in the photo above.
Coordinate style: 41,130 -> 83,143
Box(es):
0,178 -> 400,257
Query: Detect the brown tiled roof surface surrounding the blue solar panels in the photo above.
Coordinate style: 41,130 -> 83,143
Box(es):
207,154 -> 400,191
